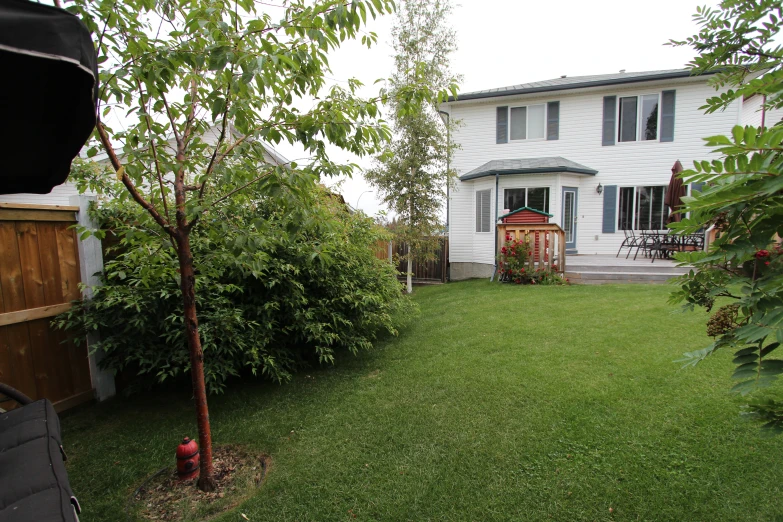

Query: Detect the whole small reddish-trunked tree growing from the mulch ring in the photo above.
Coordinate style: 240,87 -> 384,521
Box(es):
67,0 -> 429,490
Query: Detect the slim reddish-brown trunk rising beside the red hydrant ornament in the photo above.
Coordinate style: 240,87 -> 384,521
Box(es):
177,230 -> 215,491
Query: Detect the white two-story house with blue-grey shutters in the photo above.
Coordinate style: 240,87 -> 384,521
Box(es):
441,69 -> 772,280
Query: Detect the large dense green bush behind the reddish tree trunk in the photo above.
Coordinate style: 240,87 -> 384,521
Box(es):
56,183 -> 415,393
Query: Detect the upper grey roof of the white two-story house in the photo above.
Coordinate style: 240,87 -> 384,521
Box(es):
449,69 -> 716,102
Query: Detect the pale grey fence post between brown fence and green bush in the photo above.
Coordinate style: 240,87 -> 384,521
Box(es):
69,196 -> 117,401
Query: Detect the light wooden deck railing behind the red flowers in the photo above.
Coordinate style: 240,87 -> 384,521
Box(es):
496,223 -> 566,273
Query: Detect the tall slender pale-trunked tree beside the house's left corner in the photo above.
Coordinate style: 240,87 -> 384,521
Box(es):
365,0 -> 460,293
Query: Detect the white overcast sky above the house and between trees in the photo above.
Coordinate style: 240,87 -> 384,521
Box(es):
266,0 -> 715,216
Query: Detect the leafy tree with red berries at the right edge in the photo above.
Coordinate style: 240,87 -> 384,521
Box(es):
671,0 -> 783,433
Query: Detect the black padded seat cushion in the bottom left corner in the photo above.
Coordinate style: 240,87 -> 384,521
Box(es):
0,399 -> 76,522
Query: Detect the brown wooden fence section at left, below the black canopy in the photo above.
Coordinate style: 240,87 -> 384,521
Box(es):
0,203 -> 93,410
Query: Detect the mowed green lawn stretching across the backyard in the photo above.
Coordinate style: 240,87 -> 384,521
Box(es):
63,281 -> 783,522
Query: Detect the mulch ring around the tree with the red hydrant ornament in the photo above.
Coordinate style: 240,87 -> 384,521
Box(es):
129,446 -> 270,521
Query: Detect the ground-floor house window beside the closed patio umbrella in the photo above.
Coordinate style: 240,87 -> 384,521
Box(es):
617,185 -> 669,230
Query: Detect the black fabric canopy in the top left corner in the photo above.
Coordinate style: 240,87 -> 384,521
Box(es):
0,0 -> 98,194
